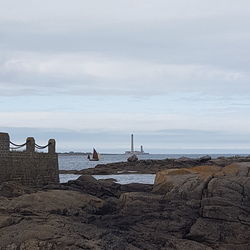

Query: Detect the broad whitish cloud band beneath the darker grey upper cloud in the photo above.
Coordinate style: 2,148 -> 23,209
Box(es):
0,52 -> 250,95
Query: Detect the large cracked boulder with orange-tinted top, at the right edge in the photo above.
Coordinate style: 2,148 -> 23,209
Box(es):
153,162 -> 250,249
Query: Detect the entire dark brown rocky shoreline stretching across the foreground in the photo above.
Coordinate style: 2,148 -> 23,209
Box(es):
0,157 -> 250,250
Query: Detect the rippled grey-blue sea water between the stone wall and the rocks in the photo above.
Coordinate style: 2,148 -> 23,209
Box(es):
58,154 -> 244,184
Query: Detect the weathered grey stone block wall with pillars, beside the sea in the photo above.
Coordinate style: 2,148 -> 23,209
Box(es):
0,133 -> 59,186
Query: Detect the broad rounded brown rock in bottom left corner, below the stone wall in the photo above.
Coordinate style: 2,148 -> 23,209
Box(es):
0,190 -> 105,250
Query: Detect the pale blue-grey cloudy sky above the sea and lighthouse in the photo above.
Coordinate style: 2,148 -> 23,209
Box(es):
0,0 -> 250,153
